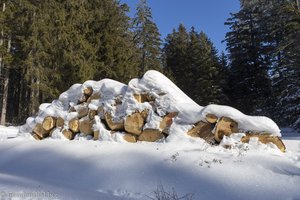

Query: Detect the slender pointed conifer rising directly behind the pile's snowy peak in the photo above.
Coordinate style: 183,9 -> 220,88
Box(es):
133,0 -> 162,75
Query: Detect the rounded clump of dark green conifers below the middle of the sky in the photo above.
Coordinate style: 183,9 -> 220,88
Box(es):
164,24 -> 226,105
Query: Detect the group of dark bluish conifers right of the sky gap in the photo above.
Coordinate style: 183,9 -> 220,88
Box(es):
225,0 -> 300,126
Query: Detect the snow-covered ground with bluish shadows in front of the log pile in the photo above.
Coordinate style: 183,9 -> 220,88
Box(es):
0,127 -> 300,200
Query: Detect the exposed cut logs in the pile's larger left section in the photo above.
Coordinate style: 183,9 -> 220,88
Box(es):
32,88 -> 178,143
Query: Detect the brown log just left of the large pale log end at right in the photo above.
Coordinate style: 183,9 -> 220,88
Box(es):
187,121 -> 214,143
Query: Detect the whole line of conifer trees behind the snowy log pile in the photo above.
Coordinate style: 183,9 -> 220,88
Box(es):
0,0 -> 300,128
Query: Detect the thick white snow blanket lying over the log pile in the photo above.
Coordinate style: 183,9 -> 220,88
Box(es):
20,70 -> 281,139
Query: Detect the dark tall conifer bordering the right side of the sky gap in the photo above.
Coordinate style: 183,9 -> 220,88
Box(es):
225,4 -> 271,114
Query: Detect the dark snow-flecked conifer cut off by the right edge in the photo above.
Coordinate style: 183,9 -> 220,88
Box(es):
264,1 -> 300,129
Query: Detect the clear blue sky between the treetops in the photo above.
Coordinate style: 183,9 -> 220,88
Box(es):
121,0 -> 239,52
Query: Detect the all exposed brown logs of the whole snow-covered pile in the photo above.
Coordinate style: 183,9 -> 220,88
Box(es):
32,88 -> 285,152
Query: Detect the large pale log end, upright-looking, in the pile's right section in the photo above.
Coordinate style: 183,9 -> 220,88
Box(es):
214,117 -> 239,142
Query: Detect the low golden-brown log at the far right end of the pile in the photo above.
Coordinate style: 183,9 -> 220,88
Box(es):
241,133 -> 286,152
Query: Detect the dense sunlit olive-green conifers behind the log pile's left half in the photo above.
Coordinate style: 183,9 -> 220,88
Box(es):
0,0 -> 138,121
